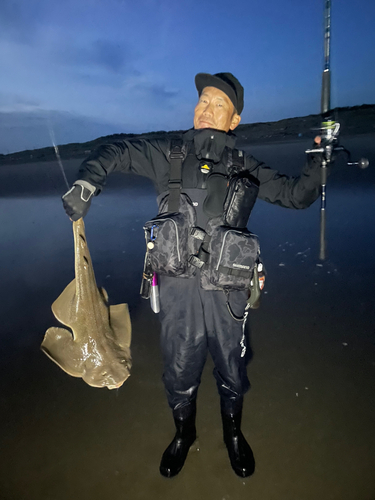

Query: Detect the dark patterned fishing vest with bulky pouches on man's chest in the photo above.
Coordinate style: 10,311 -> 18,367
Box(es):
144,139 -> 260,290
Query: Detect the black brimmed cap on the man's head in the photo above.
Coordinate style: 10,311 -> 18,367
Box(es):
195,73 -> 243,115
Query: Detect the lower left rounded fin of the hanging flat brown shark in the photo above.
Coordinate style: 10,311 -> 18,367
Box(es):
41,327 -> 84,377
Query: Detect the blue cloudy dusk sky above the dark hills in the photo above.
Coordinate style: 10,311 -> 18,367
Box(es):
0,0 -> 375,153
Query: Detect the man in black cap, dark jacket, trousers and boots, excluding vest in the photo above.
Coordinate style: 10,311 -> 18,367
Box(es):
63,73 -> 320,477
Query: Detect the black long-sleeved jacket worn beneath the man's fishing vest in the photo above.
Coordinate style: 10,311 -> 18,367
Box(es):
79,129 -> 320,227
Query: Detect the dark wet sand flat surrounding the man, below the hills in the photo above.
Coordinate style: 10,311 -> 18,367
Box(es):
0,135 -> 375,500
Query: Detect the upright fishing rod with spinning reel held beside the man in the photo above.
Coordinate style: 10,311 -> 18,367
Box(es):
306,0 -> 369,260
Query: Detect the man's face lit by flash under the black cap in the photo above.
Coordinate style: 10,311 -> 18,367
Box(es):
194,87 -> 241,132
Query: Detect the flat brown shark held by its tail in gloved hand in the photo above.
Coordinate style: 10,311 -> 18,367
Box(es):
41,219 -> 131,389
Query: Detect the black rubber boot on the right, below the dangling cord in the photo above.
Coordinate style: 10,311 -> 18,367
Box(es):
221,402 -> 255,477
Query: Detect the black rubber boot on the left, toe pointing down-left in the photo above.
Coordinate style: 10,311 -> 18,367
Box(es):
160,401 -> 197,477
